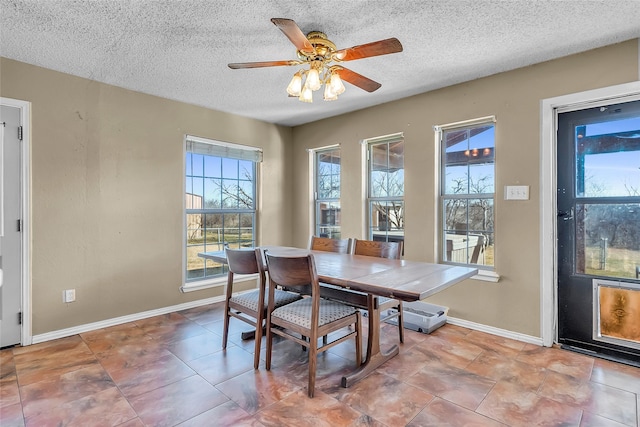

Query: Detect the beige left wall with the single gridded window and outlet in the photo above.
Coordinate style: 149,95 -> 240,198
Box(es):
0,58 -> 292,335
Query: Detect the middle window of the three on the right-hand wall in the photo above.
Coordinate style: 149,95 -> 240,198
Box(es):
366,134 -> 404,247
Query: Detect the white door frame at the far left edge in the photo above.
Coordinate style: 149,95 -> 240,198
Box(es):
0,97 -> 32,346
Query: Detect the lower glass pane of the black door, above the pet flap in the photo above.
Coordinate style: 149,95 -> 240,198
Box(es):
575,203 -> 640,279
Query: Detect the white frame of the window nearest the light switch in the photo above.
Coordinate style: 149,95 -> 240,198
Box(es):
433,116 -> 499,282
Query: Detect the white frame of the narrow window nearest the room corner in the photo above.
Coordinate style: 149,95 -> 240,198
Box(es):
309,144 -> 342,239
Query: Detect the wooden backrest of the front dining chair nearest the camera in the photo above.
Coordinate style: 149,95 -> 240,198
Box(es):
265,252 -> 320,294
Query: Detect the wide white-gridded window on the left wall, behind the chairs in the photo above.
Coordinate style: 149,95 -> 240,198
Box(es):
185,136 -> 262,282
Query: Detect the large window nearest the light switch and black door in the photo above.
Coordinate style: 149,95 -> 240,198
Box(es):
435,117 -> 495,267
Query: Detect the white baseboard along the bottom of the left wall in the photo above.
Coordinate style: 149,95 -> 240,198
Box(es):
31,295 -> 225,344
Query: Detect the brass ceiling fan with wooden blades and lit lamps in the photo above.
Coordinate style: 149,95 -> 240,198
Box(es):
229,18 -> 402,102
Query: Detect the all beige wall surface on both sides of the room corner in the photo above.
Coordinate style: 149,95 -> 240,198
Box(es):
0,40 -> 639,342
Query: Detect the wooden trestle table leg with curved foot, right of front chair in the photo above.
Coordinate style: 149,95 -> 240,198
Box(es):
341,294 -> 400,388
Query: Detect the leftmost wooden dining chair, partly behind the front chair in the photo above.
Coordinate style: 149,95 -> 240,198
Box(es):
222,248 -> 301,369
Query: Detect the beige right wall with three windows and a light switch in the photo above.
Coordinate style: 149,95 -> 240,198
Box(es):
293,40 -> 639,337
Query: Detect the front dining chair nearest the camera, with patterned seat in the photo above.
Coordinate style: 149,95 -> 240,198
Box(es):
265,252 -> 362,397
